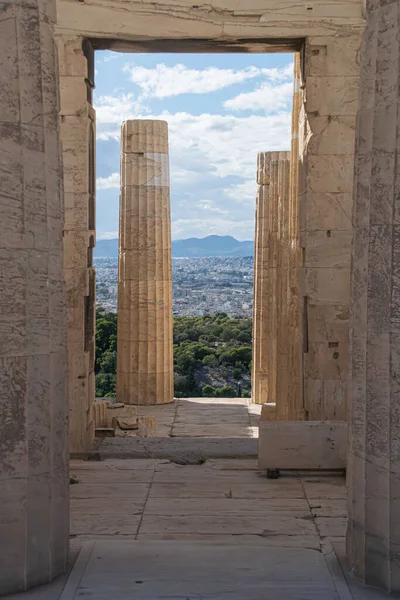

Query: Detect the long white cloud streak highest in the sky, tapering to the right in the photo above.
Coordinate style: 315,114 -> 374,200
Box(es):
124,63 -> 293,98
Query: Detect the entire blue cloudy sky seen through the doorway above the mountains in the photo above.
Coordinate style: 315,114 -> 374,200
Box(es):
94,51 -> 293,240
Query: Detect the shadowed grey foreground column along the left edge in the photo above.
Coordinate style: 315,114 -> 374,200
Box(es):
0,0 -> 69,595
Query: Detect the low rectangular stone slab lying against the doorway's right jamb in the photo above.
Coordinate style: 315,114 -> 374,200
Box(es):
258,421 -> 346,469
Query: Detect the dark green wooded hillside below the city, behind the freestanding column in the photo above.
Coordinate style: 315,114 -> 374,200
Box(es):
95,309 -> 252,398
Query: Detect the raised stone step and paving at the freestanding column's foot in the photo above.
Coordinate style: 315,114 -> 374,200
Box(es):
88,398 -> 261,462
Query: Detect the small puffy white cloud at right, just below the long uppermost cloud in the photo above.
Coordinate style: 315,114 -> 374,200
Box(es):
224,82 -> 293,113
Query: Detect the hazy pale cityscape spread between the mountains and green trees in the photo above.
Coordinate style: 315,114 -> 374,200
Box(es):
95,256 -> 254,317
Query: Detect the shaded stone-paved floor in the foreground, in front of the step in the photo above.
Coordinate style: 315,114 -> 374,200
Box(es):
4,459 -> 385,600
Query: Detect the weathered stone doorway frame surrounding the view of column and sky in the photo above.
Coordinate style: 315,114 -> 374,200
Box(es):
62,27 -> 361,453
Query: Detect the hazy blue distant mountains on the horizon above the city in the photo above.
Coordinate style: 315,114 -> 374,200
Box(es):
95,235 -> 254,258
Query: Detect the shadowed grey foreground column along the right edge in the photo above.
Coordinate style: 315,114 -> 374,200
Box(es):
347,0 -> 400,593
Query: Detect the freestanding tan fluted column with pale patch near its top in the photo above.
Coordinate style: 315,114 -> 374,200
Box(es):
117,120 -> 174,405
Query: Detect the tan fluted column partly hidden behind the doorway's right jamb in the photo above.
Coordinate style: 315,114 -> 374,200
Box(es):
253,152 -> 290,418
